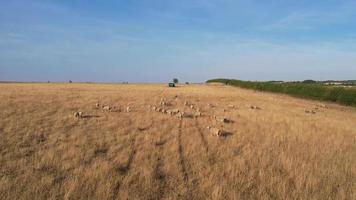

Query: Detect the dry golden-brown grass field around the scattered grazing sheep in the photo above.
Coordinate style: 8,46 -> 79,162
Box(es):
0,83 -> 356,200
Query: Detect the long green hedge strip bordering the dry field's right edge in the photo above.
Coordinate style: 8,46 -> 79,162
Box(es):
207,79 -> 356,106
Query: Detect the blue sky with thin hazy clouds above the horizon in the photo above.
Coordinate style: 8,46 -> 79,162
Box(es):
0,0 -> 356,82
